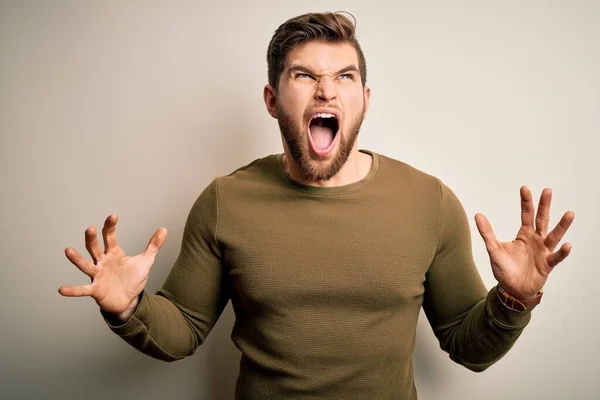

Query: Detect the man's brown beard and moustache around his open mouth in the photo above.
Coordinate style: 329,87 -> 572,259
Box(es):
276,101 -> 365,181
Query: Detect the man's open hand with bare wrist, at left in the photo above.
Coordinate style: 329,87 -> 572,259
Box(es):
58,214 -> 167,322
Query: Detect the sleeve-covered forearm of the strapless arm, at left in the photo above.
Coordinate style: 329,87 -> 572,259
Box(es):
102,292 -> 199,361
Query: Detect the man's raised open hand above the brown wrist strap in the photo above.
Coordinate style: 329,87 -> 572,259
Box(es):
475,186 -> 575,300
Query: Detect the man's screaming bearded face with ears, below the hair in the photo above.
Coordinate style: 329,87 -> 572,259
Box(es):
265,41 -> 370,181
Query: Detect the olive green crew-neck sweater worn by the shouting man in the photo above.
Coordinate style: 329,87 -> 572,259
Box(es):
107,150 -> 530,400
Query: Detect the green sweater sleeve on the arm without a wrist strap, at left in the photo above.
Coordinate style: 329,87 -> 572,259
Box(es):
104,180 -> 229,361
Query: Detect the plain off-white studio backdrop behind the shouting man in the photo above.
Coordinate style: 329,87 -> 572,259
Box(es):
0,0 -> 600,400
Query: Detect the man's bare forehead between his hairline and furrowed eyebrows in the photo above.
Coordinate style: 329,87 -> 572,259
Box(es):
284,41 -> 358,72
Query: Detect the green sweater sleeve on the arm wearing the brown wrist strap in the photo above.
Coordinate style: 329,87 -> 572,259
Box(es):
423,182 -> 531,372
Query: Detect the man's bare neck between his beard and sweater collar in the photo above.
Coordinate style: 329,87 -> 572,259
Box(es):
283,143 -> 373,187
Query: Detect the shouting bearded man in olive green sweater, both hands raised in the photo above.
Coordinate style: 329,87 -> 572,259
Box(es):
59,13 -> 574,400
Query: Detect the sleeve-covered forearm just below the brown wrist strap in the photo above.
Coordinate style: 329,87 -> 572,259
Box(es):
436,287 -> 531,372
